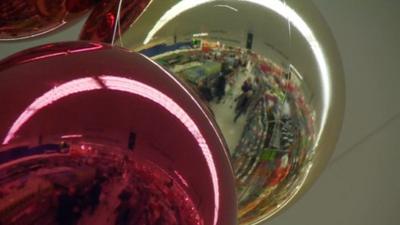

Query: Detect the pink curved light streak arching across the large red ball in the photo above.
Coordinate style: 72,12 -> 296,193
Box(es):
3,76 -> 220,224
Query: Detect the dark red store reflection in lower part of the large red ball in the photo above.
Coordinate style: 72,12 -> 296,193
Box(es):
0,138 -> 202,225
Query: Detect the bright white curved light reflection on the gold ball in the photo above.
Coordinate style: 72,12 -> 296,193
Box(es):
143,0 -> 331,146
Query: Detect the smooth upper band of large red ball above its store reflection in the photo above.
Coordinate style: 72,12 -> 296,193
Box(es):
0,42 -> 236,225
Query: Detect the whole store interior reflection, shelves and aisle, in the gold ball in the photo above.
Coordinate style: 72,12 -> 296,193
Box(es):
142,39 -> 313,222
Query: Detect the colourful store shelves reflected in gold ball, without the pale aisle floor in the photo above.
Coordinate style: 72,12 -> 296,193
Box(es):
150,41 -> 314,221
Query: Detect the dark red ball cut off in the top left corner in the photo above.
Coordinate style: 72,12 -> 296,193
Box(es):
0,0 -> 98,40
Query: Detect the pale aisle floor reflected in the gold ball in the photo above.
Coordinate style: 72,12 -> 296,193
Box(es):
210,71 -> 250,154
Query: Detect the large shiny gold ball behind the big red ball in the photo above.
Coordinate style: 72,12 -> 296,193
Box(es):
89,0 -> 344,224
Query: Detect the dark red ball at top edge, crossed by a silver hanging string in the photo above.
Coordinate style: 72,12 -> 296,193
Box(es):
80,0 -> 150,43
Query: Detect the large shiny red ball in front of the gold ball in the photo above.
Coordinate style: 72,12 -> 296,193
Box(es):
0,42 -> 237,225
